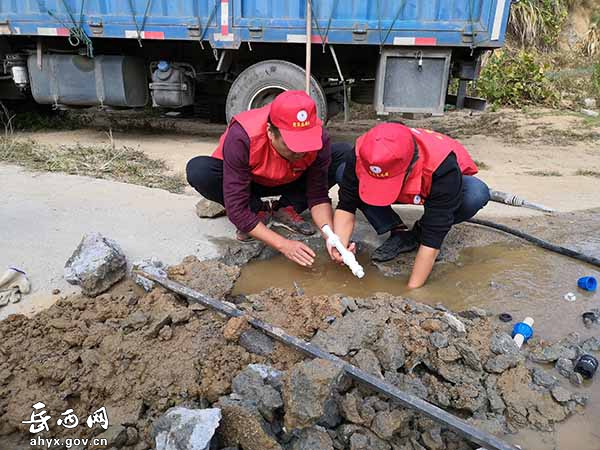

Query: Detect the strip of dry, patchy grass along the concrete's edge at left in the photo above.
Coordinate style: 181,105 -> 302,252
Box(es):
0,138 -> 186,193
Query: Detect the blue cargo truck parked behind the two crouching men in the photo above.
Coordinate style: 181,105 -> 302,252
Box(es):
0,0 -> 511,120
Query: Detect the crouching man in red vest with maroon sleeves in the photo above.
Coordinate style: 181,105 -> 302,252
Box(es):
186,91 -> 345,266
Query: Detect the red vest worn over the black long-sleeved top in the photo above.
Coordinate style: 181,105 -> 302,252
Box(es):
357,128 -> 477,205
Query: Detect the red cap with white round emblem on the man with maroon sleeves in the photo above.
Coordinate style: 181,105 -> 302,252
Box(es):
269,91 -> 323,153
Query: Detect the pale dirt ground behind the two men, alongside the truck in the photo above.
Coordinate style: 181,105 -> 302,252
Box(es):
17,105 -> 600,217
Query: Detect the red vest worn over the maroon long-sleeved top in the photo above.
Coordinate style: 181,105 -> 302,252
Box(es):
212,105 -> 318,187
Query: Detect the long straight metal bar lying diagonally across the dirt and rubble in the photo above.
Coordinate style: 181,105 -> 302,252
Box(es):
133,270 -> 519,450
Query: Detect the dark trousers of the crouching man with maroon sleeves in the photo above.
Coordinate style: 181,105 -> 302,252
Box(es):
186,144 -> 352,214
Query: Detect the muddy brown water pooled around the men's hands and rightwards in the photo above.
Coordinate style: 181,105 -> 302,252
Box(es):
234,240 -> 600,450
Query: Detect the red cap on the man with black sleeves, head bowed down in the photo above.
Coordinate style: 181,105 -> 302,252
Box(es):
356,123 -> 415,206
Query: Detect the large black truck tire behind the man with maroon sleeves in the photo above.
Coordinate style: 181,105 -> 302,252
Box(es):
226,59 -> 327,123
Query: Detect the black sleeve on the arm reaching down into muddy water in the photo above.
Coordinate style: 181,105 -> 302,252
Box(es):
420,153 -> 462,249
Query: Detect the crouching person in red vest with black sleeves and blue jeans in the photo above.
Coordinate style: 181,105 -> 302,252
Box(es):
329,123 -> 490,289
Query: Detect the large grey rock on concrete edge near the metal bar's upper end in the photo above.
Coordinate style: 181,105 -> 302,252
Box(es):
64,233 -> 127,297
